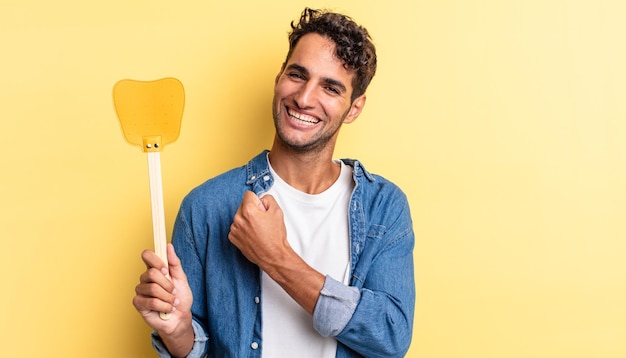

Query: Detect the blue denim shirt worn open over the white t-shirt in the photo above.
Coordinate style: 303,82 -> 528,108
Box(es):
153,151 -> 415,358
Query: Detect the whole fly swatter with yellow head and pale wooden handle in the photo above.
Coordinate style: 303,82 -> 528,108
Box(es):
113,78 -> 185,319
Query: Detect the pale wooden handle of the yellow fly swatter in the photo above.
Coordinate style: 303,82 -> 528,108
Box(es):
148,152 -> 171,320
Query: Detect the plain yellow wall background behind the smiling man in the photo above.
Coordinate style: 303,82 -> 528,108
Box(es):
0,0 -> 626,358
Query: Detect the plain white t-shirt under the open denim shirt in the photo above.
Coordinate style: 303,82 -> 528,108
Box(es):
261,162 -> 354,358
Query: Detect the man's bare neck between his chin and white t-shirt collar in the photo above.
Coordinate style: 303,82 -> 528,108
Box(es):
269,141 -> 341,194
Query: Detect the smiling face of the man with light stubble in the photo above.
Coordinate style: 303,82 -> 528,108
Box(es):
273,33 -> 365,152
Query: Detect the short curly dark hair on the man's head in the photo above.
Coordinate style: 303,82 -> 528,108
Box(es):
285,8 -> 376,101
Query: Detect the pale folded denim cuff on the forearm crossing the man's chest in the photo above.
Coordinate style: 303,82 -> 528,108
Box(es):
313,276 -> 361,337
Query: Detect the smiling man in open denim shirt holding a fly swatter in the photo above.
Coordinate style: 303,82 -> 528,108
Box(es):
133,9 -> 415,358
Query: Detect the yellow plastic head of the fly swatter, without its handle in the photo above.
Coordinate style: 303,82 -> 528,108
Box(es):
113,77 -> 185,152
